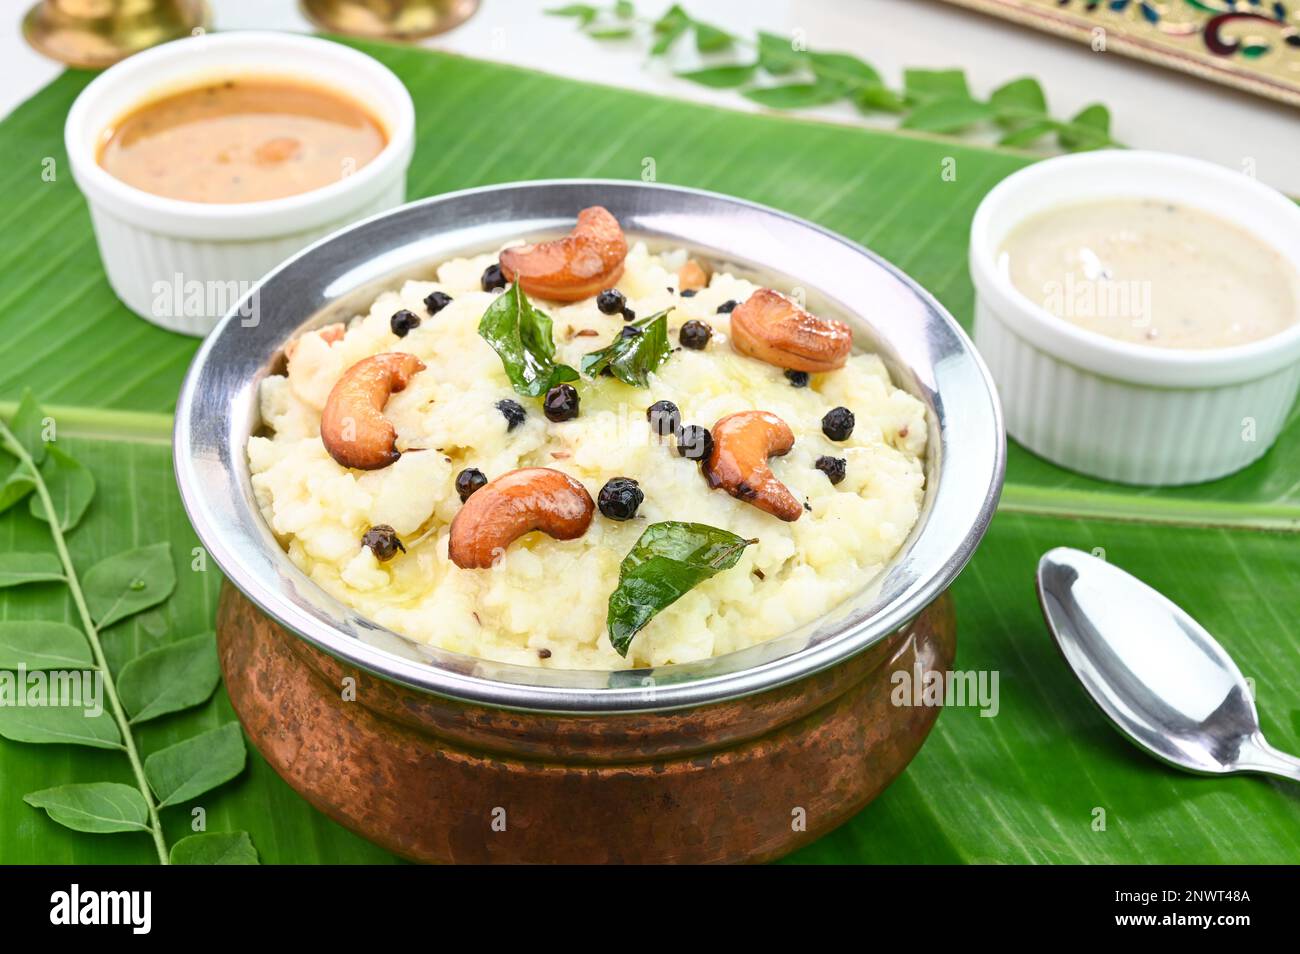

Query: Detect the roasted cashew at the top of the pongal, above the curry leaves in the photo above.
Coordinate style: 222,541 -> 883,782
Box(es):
501,205 -> 628,302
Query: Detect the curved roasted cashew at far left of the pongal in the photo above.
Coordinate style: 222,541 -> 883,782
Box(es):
321,351 -> 424,471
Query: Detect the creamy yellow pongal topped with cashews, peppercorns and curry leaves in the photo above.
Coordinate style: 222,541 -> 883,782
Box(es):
248,207 -> 927,669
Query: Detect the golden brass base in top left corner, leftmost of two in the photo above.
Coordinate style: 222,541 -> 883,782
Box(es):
22,0 -> 209,69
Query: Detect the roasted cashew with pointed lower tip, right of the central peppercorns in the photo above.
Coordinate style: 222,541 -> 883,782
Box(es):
705,411 -> 803,521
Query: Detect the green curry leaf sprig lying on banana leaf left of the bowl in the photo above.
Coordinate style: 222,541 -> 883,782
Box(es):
0,391 -> 257,864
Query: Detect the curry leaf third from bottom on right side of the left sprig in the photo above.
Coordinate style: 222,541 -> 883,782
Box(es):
117,633 -> 221,724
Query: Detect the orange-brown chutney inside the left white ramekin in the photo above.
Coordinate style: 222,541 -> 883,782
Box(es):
99,77 -> 387,203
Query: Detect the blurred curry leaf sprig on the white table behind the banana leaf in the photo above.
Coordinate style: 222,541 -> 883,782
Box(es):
547,0 -> 1119,152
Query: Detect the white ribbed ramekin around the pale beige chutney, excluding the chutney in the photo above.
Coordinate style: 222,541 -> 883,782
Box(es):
970,151 -> 1300,485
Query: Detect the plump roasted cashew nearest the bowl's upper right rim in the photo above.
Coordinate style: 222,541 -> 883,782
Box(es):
731,289 -> 853,372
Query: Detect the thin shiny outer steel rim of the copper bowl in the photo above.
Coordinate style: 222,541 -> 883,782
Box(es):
173,178 -> 1006,714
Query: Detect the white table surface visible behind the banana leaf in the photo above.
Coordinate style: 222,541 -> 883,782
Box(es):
0,0 -> 1300,196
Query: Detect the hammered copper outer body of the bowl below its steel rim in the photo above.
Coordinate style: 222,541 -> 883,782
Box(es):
217,585 -> 956,864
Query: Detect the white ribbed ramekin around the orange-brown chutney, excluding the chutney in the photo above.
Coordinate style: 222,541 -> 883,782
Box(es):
64,32 -> 415,335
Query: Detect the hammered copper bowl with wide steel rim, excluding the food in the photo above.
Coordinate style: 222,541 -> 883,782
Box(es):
176,181 -> 1005,862
